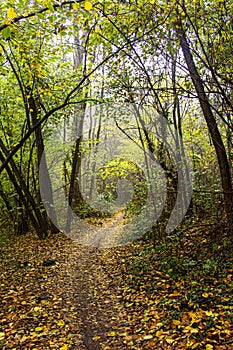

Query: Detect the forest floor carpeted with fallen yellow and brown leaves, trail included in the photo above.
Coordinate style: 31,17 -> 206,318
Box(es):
0,221 -> 233,350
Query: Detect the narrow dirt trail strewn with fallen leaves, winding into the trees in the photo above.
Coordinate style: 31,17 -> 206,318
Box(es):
63,210 -> 128,350
